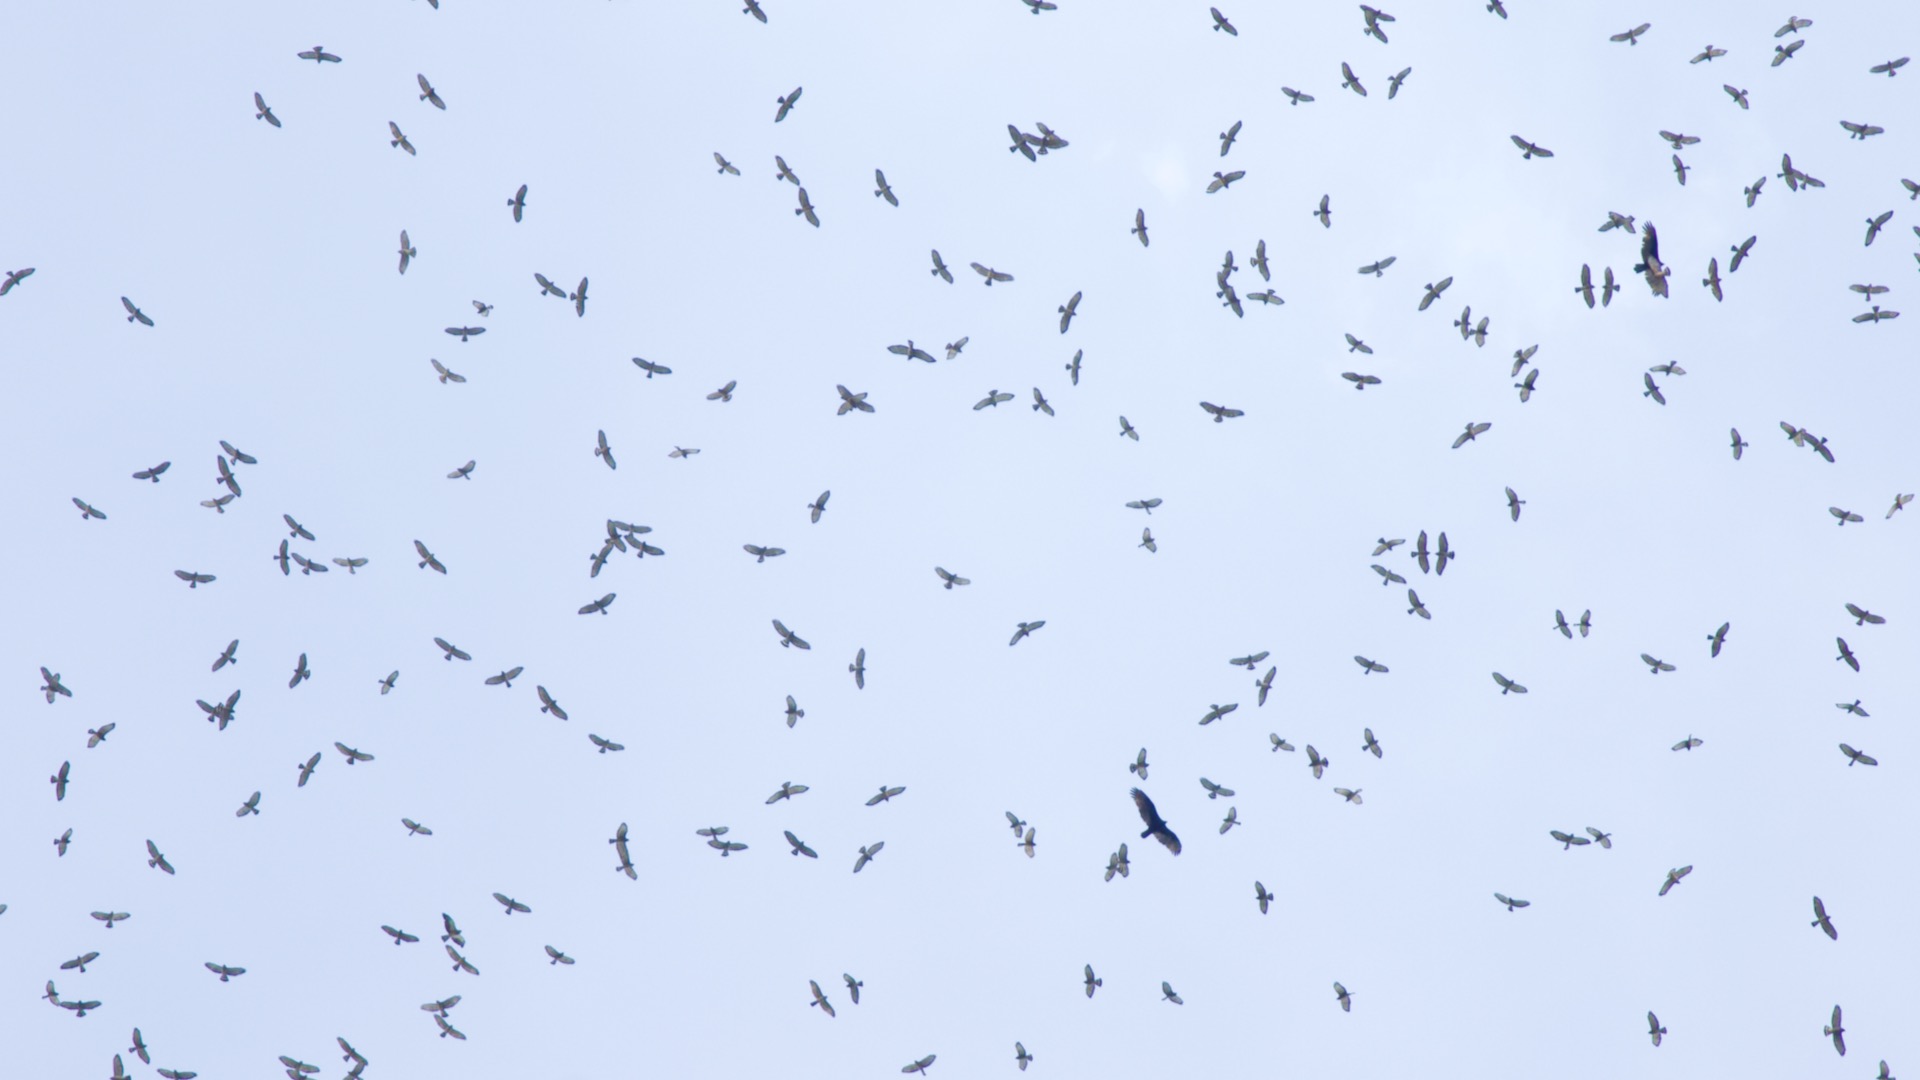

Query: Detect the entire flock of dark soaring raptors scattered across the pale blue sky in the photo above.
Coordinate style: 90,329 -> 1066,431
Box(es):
0,0 -> 1920,1080
